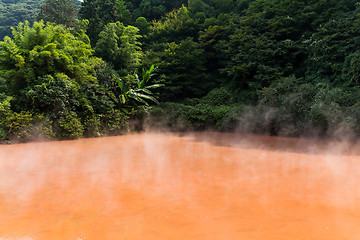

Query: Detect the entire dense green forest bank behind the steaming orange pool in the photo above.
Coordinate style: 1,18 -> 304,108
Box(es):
0,0 -> 360,141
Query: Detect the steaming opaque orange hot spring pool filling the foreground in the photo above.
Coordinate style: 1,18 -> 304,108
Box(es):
0,133 -> 360,240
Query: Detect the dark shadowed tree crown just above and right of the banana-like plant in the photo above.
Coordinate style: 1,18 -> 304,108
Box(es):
147,38 -> 217,101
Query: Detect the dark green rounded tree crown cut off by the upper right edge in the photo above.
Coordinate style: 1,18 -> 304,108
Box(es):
304,7 -> 360,86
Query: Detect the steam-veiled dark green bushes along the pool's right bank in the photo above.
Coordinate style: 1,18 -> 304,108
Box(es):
260,76 -> 360,136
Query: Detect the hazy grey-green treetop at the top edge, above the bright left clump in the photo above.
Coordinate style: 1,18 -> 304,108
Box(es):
37,0 -> 77,27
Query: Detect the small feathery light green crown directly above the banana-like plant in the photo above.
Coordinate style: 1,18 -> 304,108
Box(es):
95,22 -> 142,76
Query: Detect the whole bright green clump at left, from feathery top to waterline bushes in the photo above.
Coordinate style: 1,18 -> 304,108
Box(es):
0,22 -> 133,140
